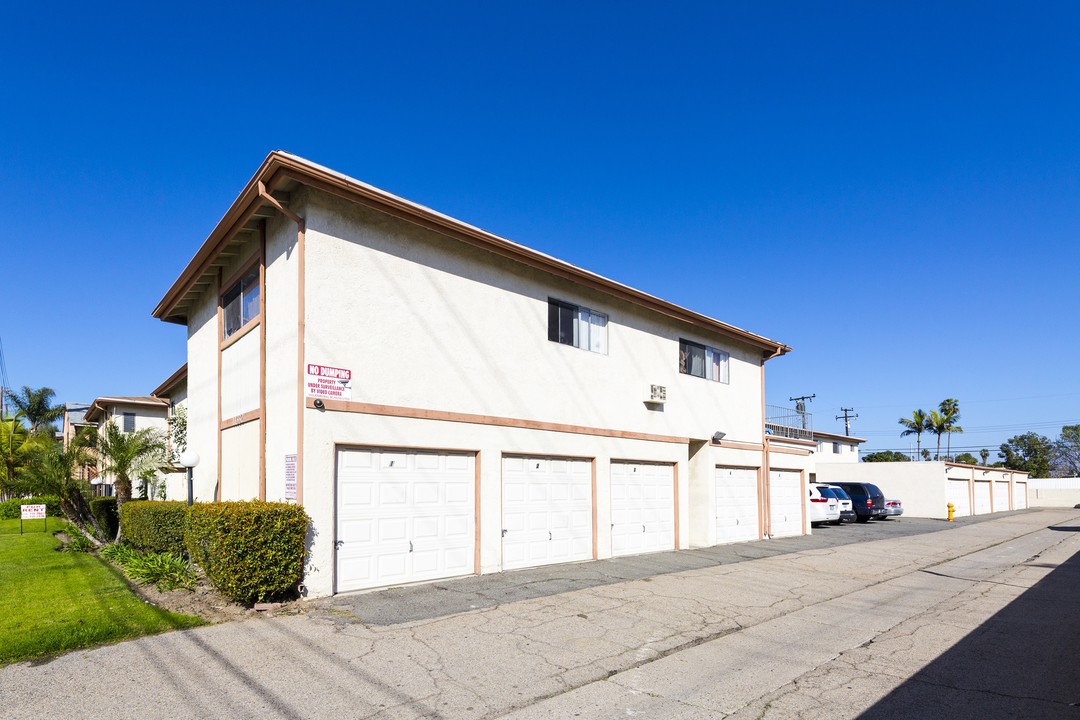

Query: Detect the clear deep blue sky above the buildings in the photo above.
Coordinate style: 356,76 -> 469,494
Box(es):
0,2 -> 1080,450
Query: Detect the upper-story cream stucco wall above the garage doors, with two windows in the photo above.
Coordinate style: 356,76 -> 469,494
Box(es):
307,188 -> 762,441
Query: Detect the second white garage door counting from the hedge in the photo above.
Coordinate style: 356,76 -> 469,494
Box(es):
502,457 -> 593,570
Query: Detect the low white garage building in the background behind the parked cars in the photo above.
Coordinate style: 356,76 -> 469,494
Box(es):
816,462 -> 1027,519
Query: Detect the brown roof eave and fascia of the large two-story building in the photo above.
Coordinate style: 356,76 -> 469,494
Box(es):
153,150 -> 792,359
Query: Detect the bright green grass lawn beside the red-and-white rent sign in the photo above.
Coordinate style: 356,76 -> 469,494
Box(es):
0,518 -> 204,666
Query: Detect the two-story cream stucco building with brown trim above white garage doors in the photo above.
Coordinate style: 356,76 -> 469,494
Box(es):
153,152 -> 814,596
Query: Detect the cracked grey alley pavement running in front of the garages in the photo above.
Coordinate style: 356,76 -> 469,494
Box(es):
0,510 -> 1080,720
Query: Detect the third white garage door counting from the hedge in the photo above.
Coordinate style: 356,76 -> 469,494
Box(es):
611,462 -> 675,556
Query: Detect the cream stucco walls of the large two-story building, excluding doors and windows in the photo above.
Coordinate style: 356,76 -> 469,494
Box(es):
177,185 -> 794,596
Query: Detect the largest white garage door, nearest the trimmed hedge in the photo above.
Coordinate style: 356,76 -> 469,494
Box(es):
335,448 -> 476,593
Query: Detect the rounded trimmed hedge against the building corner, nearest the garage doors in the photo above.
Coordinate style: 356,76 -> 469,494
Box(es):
184,500 -> 310,603
